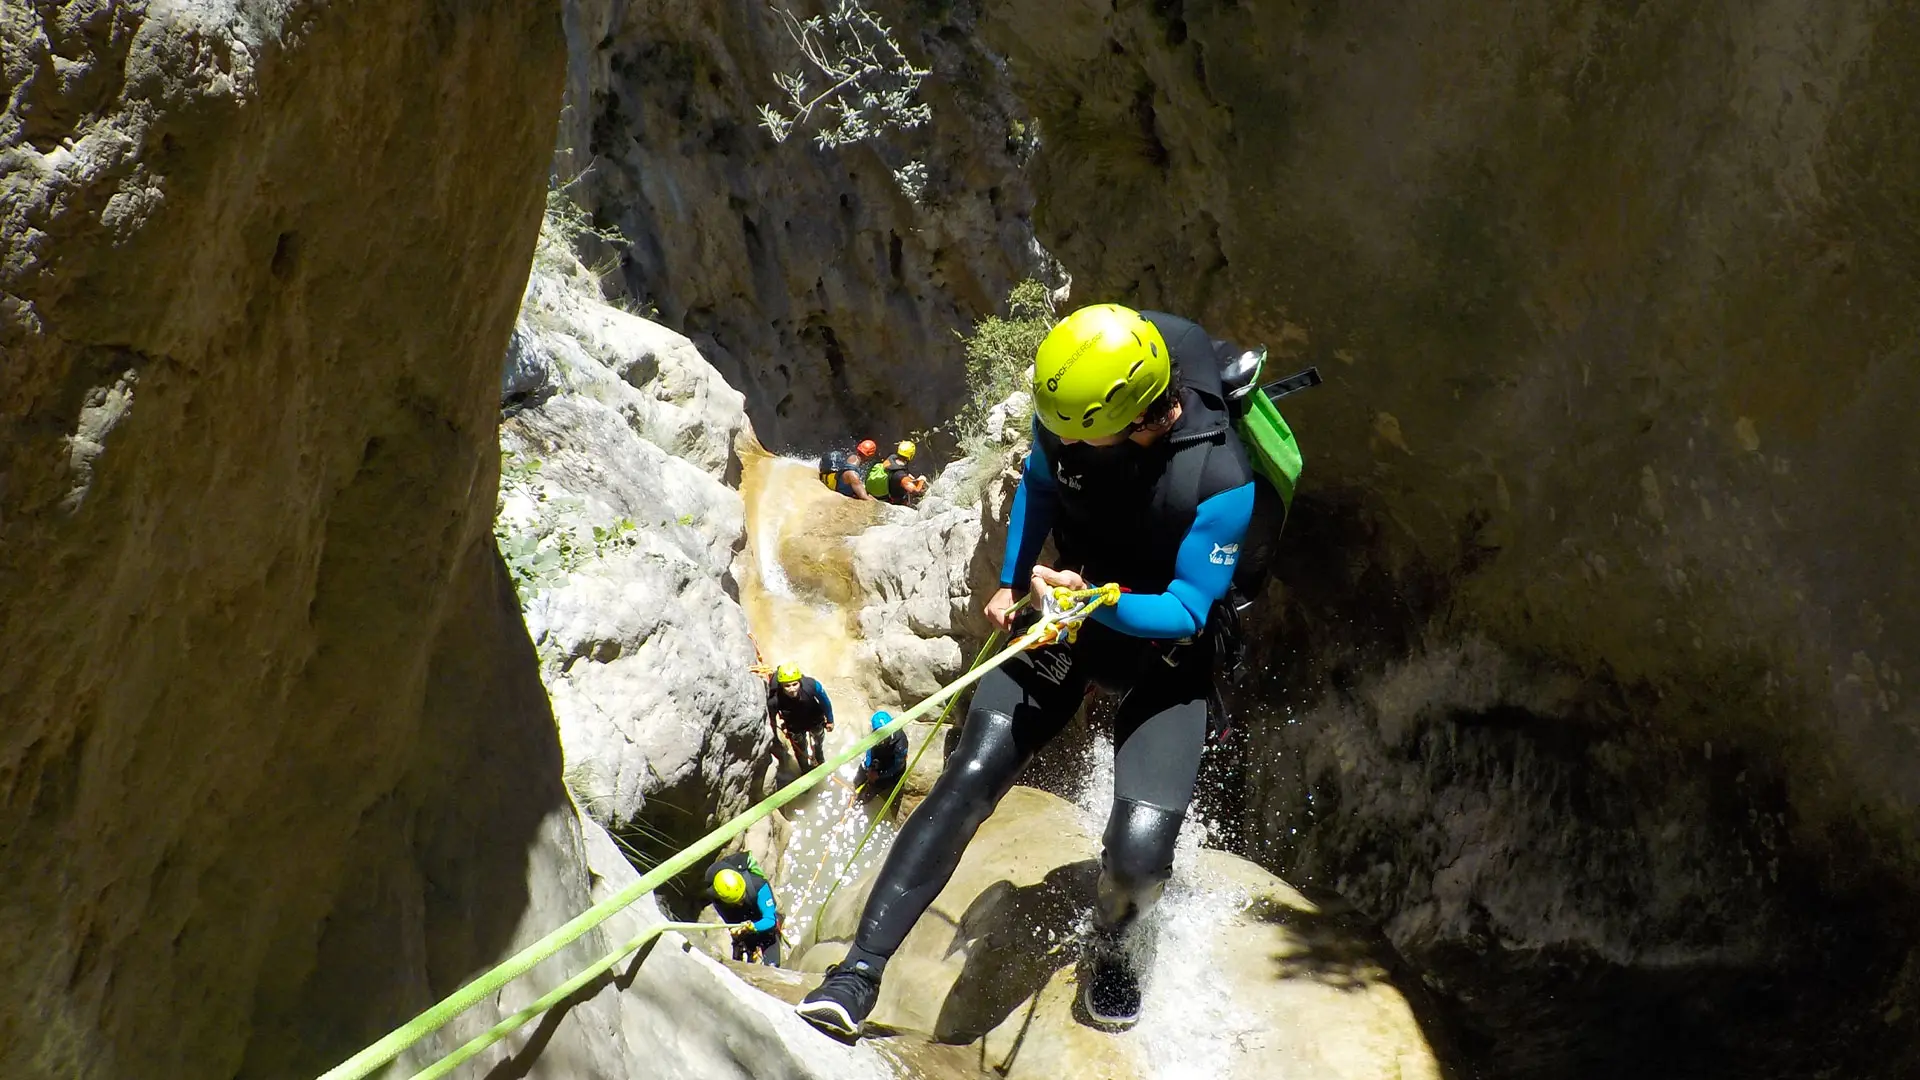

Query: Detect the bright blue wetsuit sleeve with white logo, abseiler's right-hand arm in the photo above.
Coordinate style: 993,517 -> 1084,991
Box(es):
1092,480 -> 1254,640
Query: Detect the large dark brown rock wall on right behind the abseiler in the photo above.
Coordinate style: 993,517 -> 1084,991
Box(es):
979,0 -> 1920,1076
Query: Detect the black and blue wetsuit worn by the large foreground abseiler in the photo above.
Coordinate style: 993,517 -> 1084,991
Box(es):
849,311 -> 1254,974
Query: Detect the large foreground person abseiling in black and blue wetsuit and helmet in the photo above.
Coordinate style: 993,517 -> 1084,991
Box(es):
797,304 -> 1256,1036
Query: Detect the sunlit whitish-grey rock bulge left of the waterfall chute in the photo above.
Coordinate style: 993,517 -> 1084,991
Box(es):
495,247 -> 770,849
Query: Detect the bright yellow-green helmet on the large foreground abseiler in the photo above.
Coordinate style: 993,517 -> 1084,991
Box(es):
1033,304 -> 1173,438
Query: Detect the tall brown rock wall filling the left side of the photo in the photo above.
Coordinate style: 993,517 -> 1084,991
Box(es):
0,0 -> 587,1078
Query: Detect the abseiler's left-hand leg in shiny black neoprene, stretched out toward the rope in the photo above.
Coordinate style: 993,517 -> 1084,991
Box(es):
849,650 -> 1087,969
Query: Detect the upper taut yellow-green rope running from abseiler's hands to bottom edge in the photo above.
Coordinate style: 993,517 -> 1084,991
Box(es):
319,601 -> 1098,1080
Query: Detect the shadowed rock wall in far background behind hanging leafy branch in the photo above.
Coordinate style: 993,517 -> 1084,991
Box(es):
555,0 -> 1041,452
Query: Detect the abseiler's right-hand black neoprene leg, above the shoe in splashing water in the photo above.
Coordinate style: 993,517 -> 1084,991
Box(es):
1098,657 -> 1210,930
